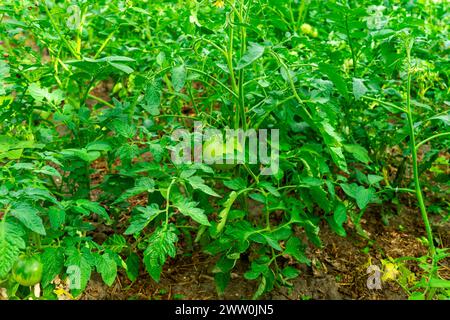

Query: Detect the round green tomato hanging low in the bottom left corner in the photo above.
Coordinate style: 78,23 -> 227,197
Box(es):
13,255 -> 42,287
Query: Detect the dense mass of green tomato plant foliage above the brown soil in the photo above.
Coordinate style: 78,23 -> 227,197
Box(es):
0,0 -> 450,299
